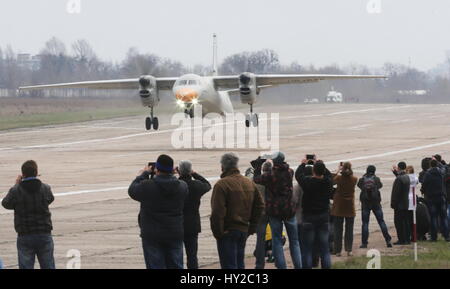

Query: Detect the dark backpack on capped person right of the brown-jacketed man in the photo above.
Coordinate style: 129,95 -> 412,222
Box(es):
266,165 -> 298,220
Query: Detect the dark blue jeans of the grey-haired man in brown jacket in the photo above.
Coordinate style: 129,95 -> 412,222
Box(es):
217,230 -> 248,269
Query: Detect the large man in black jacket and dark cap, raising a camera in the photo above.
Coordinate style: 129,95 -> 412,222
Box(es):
128,155 -> 188,269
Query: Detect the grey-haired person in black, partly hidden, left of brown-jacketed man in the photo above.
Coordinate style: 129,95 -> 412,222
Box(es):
177,161 -> 211,269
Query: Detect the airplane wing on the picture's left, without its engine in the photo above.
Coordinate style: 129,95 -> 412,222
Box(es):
19,77 -> 178,91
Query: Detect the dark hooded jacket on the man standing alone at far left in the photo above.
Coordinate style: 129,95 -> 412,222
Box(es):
2,178 -> 55,236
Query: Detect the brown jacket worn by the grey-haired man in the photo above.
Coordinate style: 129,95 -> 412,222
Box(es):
210,169 -> 264,239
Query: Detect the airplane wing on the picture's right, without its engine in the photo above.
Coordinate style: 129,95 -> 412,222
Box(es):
213,74 -> 386,88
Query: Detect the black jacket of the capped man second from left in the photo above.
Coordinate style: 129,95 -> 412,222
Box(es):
128,172 -> 188,241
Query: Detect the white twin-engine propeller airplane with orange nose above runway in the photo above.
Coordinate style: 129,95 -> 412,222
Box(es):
19,34 -> 386,130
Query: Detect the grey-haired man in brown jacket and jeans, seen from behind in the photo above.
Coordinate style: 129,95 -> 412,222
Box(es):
210,153 -> 264,269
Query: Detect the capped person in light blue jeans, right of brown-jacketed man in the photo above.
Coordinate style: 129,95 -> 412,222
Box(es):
253,152 -> 302,269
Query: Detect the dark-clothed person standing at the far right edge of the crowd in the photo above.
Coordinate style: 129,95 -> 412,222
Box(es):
422,159 -> 450,241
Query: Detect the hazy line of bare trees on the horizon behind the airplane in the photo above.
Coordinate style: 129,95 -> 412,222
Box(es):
0,37 -> 450,102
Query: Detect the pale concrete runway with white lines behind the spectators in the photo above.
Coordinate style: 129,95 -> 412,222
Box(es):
0,104 -> 450,268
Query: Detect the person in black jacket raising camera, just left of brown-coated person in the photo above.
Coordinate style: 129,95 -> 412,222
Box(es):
295,159 -> 333,269
